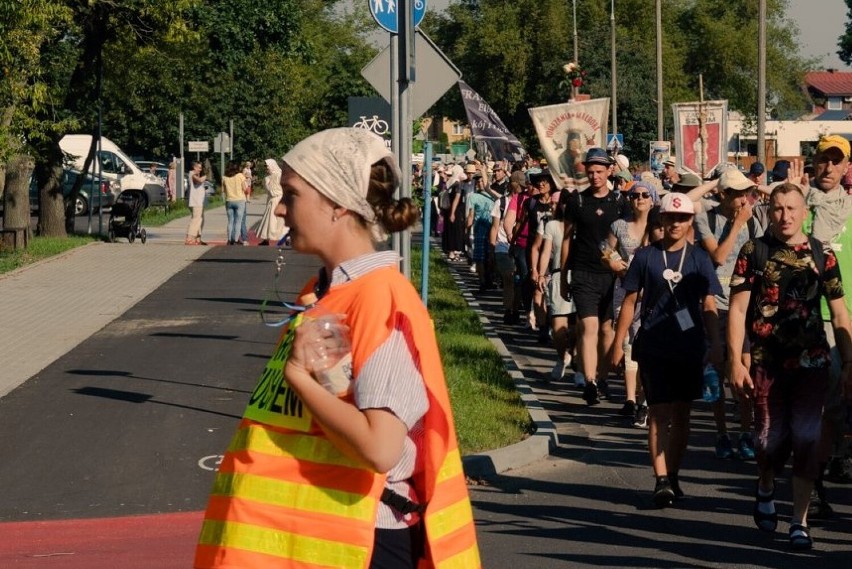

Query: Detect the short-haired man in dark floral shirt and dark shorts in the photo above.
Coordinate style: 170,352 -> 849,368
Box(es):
727,184 -> 852,550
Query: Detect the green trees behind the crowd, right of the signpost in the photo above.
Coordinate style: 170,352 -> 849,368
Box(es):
423,0 -> 812,156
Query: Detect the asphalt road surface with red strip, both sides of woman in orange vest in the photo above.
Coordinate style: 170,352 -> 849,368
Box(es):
0,214 -> 852,569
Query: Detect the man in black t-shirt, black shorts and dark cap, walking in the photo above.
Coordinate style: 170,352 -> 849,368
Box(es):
560,148 -> 627,405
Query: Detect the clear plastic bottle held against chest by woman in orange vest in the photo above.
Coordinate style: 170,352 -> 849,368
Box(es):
300,293 -> 352,397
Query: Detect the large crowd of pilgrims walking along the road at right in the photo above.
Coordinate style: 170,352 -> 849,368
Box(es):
432,135 -> 852,550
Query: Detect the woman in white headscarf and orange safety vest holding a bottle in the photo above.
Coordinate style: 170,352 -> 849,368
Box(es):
195,128 -> 481,569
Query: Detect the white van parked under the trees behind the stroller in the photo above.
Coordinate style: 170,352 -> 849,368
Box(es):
59,134 -> 166,207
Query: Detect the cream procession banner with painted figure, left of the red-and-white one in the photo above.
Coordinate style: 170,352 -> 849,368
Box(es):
529,97 -> 609,189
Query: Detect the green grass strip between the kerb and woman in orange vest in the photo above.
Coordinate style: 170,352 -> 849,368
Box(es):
411,247 -> 534,454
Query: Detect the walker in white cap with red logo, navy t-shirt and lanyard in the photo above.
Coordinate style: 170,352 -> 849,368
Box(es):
611,193 -> 722,508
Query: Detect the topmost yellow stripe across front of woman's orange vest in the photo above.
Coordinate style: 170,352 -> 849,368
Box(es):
228,426 -> 364,470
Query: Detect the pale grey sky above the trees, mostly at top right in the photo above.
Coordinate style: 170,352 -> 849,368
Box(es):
412,0 -> 852,71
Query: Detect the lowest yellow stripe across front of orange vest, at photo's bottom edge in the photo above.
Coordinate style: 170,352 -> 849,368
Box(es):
199,520 -> 369,568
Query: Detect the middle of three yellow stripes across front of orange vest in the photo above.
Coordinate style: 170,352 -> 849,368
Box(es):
211,473 -> 376,523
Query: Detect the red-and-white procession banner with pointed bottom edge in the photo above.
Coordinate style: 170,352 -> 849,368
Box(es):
672,100 -> 728,178
